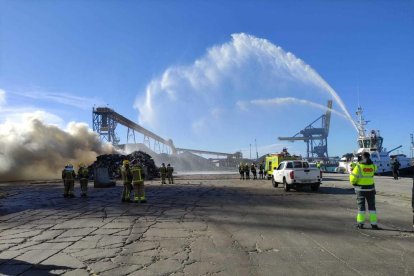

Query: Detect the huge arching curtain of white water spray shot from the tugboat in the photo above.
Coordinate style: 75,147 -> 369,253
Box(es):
134,33 -> 353,153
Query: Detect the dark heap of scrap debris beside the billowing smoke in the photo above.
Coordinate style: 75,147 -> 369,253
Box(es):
89,151 -> 158,179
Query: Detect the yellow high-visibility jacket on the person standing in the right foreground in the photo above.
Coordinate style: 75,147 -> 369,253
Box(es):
349,163 -> 377,190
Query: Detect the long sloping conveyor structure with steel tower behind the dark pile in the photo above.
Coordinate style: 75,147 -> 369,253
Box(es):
92,107 -> 242,160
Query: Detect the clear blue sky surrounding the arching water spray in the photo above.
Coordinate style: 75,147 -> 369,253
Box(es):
0,0 -> 414,155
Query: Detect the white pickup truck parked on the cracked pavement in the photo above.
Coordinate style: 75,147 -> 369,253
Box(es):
272,160 -> 322,192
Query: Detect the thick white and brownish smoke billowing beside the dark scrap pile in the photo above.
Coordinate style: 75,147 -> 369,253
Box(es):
0,111 -> 113,181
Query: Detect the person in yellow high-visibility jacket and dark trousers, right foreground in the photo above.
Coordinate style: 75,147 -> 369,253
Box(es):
349,152 -> 380,230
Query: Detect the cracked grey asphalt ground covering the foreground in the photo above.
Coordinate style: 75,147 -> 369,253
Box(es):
0,174 -> 414,275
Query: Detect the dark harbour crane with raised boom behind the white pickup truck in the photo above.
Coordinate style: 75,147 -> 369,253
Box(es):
279,100 -> 332,159
